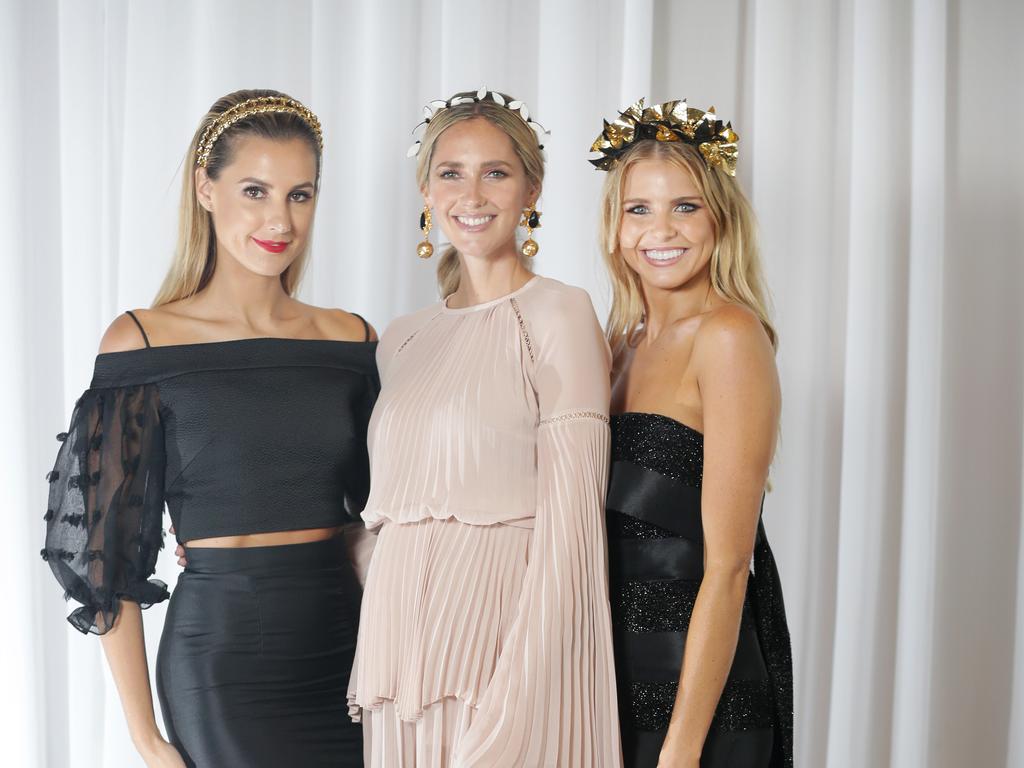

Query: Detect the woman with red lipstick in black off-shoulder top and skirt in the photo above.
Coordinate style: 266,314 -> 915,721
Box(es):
43,91 -> 379,766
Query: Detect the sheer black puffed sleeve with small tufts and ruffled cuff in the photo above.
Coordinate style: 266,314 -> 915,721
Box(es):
42,384 -> 169,635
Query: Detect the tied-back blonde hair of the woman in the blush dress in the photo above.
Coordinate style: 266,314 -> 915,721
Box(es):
416,91 -> 544,298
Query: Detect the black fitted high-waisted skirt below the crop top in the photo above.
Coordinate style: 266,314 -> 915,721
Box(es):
157,537 -> 362,768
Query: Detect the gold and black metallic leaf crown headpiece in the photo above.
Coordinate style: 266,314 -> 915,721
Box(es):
590,98 -> 739,176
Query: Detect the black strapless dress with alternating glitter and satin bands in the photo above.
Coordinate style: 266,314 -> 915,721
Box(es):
607,413 -> 793,768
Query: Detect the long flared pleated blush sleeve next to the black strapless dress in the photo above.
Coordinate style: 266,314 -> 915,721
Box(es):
456,287 -> 622,768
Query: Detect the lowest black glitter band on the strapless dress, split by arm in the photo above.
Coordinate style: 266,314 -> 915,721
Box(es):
630,680 -> 774,732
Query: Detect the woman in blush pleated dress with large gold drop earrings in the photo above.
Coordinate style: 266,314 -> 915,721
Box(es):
349,90 -> 622,768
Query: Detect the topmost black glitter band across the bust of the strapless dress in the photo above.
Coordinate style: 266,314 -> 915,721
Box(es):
611,413 -> 703,487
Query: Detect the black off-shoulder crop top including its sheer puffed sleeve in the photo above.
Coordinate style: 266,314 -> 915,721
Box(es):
42,339 -> 380,634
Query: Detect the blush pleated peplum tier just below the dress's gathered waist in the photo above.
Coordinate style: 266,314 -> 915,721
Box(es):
347,519 -> 532,723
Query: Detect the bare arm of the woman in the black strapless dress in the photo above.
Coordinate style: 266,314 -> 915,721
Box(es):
662,306 -> 779,766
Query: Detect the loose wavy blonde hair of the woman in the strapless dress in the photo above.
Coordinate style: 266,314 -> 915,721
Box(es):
600,139 -> 778,356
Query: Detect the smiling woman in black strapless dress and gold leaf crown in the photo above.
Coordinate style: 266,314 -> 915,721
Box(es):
592,101 -> 793,768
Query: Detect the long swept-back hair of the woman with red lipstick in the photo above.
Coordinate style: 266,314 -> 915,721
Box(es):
153,89 -> 322,306
